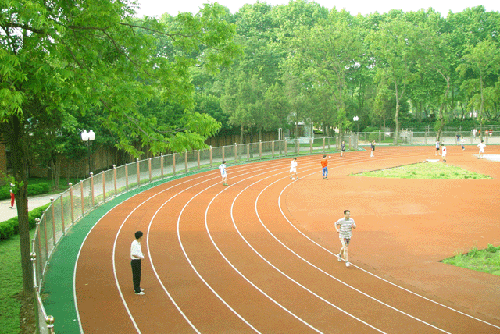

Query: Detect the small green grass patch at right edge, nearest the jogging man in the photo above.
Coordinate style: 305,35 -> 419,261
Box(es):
441,245 -> 500,276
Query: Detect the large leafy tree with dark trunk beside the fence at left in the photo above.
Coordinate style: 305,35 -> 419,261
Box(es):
0,0 -> 238,298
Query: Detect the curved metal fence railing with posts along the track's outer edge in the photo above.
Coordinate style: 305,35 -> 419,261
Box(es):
31,134 -> 366,333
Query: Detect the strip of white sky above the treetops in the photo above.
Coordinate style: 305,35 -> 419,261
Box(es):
137,0 -> 500,17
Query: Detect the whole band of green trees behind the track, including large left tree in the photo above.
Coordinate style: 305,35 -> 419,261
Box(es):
0,0 -> 500,300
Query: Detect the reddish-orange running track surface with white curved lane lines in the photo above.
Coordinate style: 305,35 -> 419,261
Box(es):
75,146 -> 500,334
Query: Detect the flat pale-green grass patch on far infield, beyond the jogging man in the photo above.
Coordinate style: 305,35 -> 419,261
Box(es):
353,162 -> 491,180
